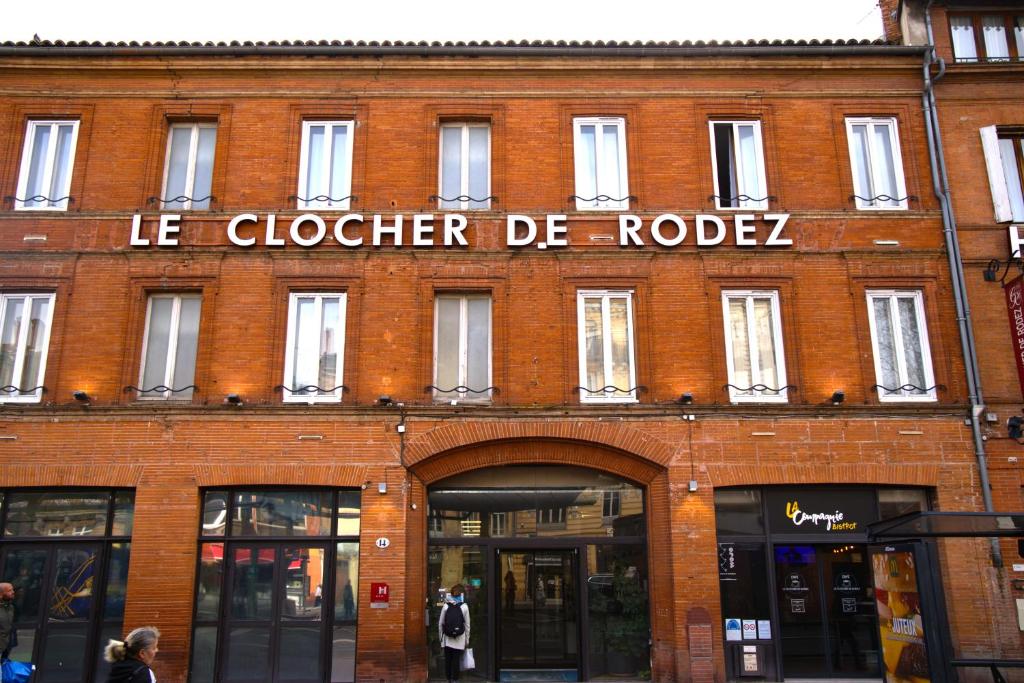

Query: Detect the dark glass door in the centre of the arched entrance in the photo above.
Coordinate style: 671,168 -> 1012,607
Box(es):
498,550 -> 579,670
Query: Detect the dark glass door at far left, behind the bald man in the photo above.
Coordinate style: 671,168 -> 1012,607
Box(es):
3,543 -> 101,683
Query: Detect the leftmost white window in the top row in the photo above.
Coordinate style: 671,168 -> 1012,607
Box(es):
14,121 -> 78,211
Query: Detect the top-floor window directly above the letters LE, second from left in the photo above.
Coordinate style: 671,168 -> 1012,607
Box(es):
161,123 -> 217,211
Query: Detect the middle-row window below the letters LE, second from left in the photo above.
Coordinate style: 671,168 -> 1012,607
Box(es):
139,294 -> 203,400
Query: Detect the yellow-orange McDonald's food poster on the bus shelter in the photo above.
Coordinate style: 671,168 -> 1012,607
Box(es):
871,548 -> 931,683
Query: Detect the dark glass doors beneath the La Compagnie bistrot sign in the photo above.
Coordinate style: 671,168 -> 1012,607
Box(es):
775,544 -> 879,678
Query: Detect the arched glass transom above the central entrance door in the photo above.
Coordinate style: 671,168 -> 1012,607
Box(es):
427,466 -> 646,539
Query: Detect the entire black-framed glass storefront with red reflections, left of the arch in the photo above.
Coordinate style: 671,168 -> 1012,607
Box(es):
189,488 -> 361,683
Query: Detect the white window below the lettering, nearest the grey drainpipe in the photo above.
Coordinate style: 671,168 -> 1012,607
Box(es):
867,290 -> 935,400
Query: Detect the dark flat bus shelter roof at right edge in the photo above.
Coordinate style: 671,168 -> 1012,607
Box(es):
867,512 -> 1024,541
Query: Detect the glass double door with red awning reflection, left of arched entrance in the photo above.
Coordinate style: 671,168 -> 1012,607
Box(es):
220,544 -> 329,683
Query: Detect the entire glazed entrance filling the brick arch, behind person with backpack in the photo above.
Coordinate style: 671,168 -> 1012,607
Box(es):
427,464 -> 650,681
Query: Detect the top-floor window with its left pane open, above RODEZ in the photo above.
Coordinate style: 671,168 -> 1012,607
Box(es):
711,121 -> 768,209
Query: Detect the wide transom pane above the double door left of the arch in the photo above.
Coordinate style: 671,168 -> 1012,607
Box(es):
231,490 -> 331,537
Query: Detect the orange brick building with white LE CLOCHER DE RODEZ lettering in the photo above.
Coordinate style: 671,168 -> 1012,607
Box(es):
0,36 -> 1016,683
